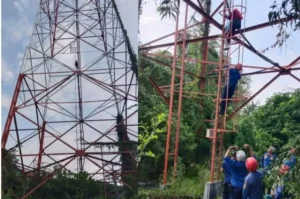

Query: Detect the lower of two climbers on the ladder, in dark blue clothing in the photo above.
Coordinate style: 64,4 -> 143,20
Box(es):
219,64 -> 243,115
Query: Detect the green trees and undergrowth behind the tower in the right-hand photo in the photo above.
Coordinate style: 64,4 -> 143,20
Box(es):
139,0 -> 300,199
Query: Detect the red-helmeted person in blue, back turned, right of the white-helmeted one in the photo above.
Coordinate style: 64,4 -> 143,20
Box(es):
243,157 -> 264,199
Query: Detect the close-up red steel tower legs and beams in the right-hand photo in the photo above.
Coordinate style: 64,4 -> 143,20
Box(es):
140,0 -> 300,184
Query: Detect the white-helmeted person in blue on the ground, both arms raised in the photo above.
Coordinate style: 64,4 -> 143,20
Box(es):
224,144 -> 253,199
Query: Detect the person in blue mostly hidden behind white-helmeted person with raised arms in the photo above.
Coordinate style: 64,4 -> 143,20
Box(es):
222,152 -> 236,199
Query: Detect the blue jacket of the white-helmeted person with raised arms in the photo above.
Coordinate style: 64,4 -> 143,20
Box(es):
224,156 -> 248,188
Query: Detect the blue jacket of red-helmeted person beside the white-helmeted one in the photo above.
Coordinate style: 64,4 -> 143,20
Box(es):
243,171 -> 264,199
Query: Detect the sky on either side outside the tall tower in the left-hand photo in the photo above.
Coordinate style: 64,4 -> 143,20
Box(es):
1,0 -> 138,128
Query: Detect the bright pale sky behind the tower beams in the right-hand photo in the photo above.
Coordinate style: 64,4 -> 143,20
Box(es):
139,0 -> 300,103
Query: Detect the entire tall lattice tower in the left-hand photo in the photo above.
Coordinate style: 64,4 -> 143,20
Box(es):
2,0 -> 137,198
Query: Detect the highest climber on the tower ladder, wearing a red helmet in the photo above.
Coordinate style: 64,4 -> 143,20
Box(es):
224,8 -> 243,50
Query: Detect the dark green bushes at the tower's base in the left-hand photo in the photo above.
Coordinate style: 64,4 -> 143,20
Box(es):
1,150 -> 122,199
